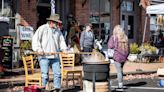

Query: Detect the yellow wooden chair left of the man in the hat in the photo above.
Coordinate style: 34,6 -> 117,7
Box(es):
22,55 -> 42,86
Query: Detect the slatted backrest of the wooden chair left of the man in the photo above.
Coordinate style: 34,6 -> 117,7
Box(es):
22,55 -> 34,76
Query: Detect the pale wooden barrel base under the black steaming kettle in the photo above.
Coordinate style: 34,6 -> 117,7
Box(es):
83,80 -> 109,92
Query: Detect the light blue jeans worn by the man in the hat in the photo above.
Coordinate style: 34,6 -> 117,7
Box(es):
39,58 -> 61,89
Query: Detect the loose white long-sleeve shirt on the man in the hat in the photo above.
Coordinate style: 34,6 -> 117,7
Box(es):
32,24 -> 67,58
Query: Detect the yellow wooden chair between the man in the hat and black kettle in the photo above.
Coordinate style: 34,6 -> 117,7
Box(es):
60,53 -> 83,89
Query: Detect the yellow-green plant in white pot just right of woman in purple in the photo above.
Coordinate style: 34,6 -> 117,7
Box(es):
128,43 -> 139,61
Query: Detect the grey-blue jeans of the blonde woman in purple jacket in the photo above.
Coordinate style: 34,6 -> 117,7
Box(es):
114,61 -> 124,83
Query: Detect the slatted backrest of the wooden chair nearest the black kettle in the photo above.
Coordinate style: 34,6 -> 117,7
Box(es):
60,53 -> 75,71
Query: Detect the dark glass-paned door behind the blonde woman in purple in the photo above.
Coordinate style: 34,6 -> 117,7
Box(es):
121,0 -> 137,42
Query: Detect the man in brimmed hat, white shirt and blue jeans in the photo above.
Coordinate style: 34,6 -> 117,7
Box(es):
32,14 -> 67,90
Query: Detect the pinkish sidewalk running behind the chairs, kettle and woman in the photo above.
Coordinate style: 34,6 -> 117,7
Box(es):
0,62 -> 164,89
